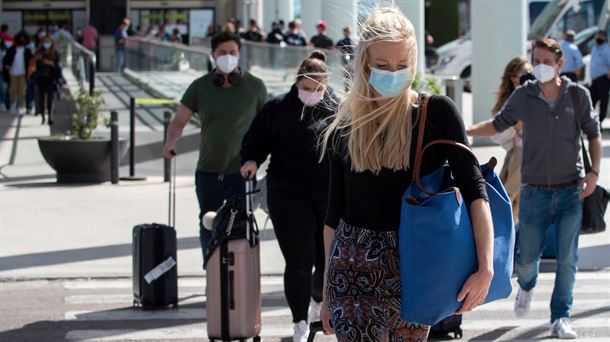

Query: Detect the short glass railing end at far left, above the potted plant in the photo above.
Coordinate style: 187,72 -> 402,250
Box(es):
65,40 -> 97,95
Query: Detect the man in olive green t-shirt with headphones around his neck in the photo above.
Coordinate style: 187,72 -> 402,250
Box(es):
163,32 -> 267,259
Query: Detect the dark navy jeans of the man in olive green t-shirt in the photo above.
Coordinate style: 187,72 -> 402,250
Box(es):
195,171 -> 246,260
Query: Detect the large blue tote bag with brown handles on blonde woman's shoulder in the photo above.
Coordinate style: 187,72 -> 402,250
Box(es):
399,98 -> 515,325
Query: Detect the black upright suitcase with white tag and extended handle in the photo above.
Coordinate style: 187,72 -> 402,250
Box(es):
132,160 -> 178,309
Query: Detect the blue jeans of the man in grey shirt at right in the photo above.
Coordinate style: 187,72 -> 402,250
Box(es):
515,185 -> 583,321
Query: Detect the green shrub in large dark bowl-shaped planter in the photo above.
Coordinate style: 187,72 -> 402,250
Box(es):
38,89 -> 127,183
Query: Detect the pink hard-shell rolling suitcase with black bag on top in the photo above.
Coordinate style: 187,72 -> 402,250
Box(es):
206,181 -> 262,342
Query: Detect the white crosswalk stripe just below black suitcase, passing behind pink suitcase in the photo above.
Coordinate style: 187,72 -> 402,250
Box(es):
64,306 -> 291,321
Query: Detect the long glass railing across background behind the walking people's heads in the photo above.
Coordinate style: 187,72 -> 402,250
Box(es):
126,38 -> 463,110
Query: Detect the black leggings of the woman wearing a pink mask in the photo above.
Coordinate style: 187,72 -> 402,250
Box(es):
267,188 -> 327,323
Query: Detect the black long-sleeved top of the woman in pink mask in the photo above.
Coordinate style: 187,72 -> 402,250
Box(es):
241,85 -> 338,195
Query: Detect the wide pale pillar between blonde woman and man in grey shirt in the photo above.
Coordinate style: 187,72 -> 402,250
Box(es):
466,0 -> 528,126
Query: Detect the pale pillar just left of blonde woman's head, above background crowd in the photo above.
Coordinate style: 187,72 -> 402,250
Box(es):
318,0 -> 358,42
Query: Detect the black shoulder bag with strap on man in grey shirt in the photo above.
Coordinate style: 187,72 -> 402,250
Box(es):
569,87 -> 610,234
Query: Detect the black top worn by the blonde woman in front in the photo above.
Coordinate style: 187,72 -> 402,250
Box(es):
325,95 -> 487,231
